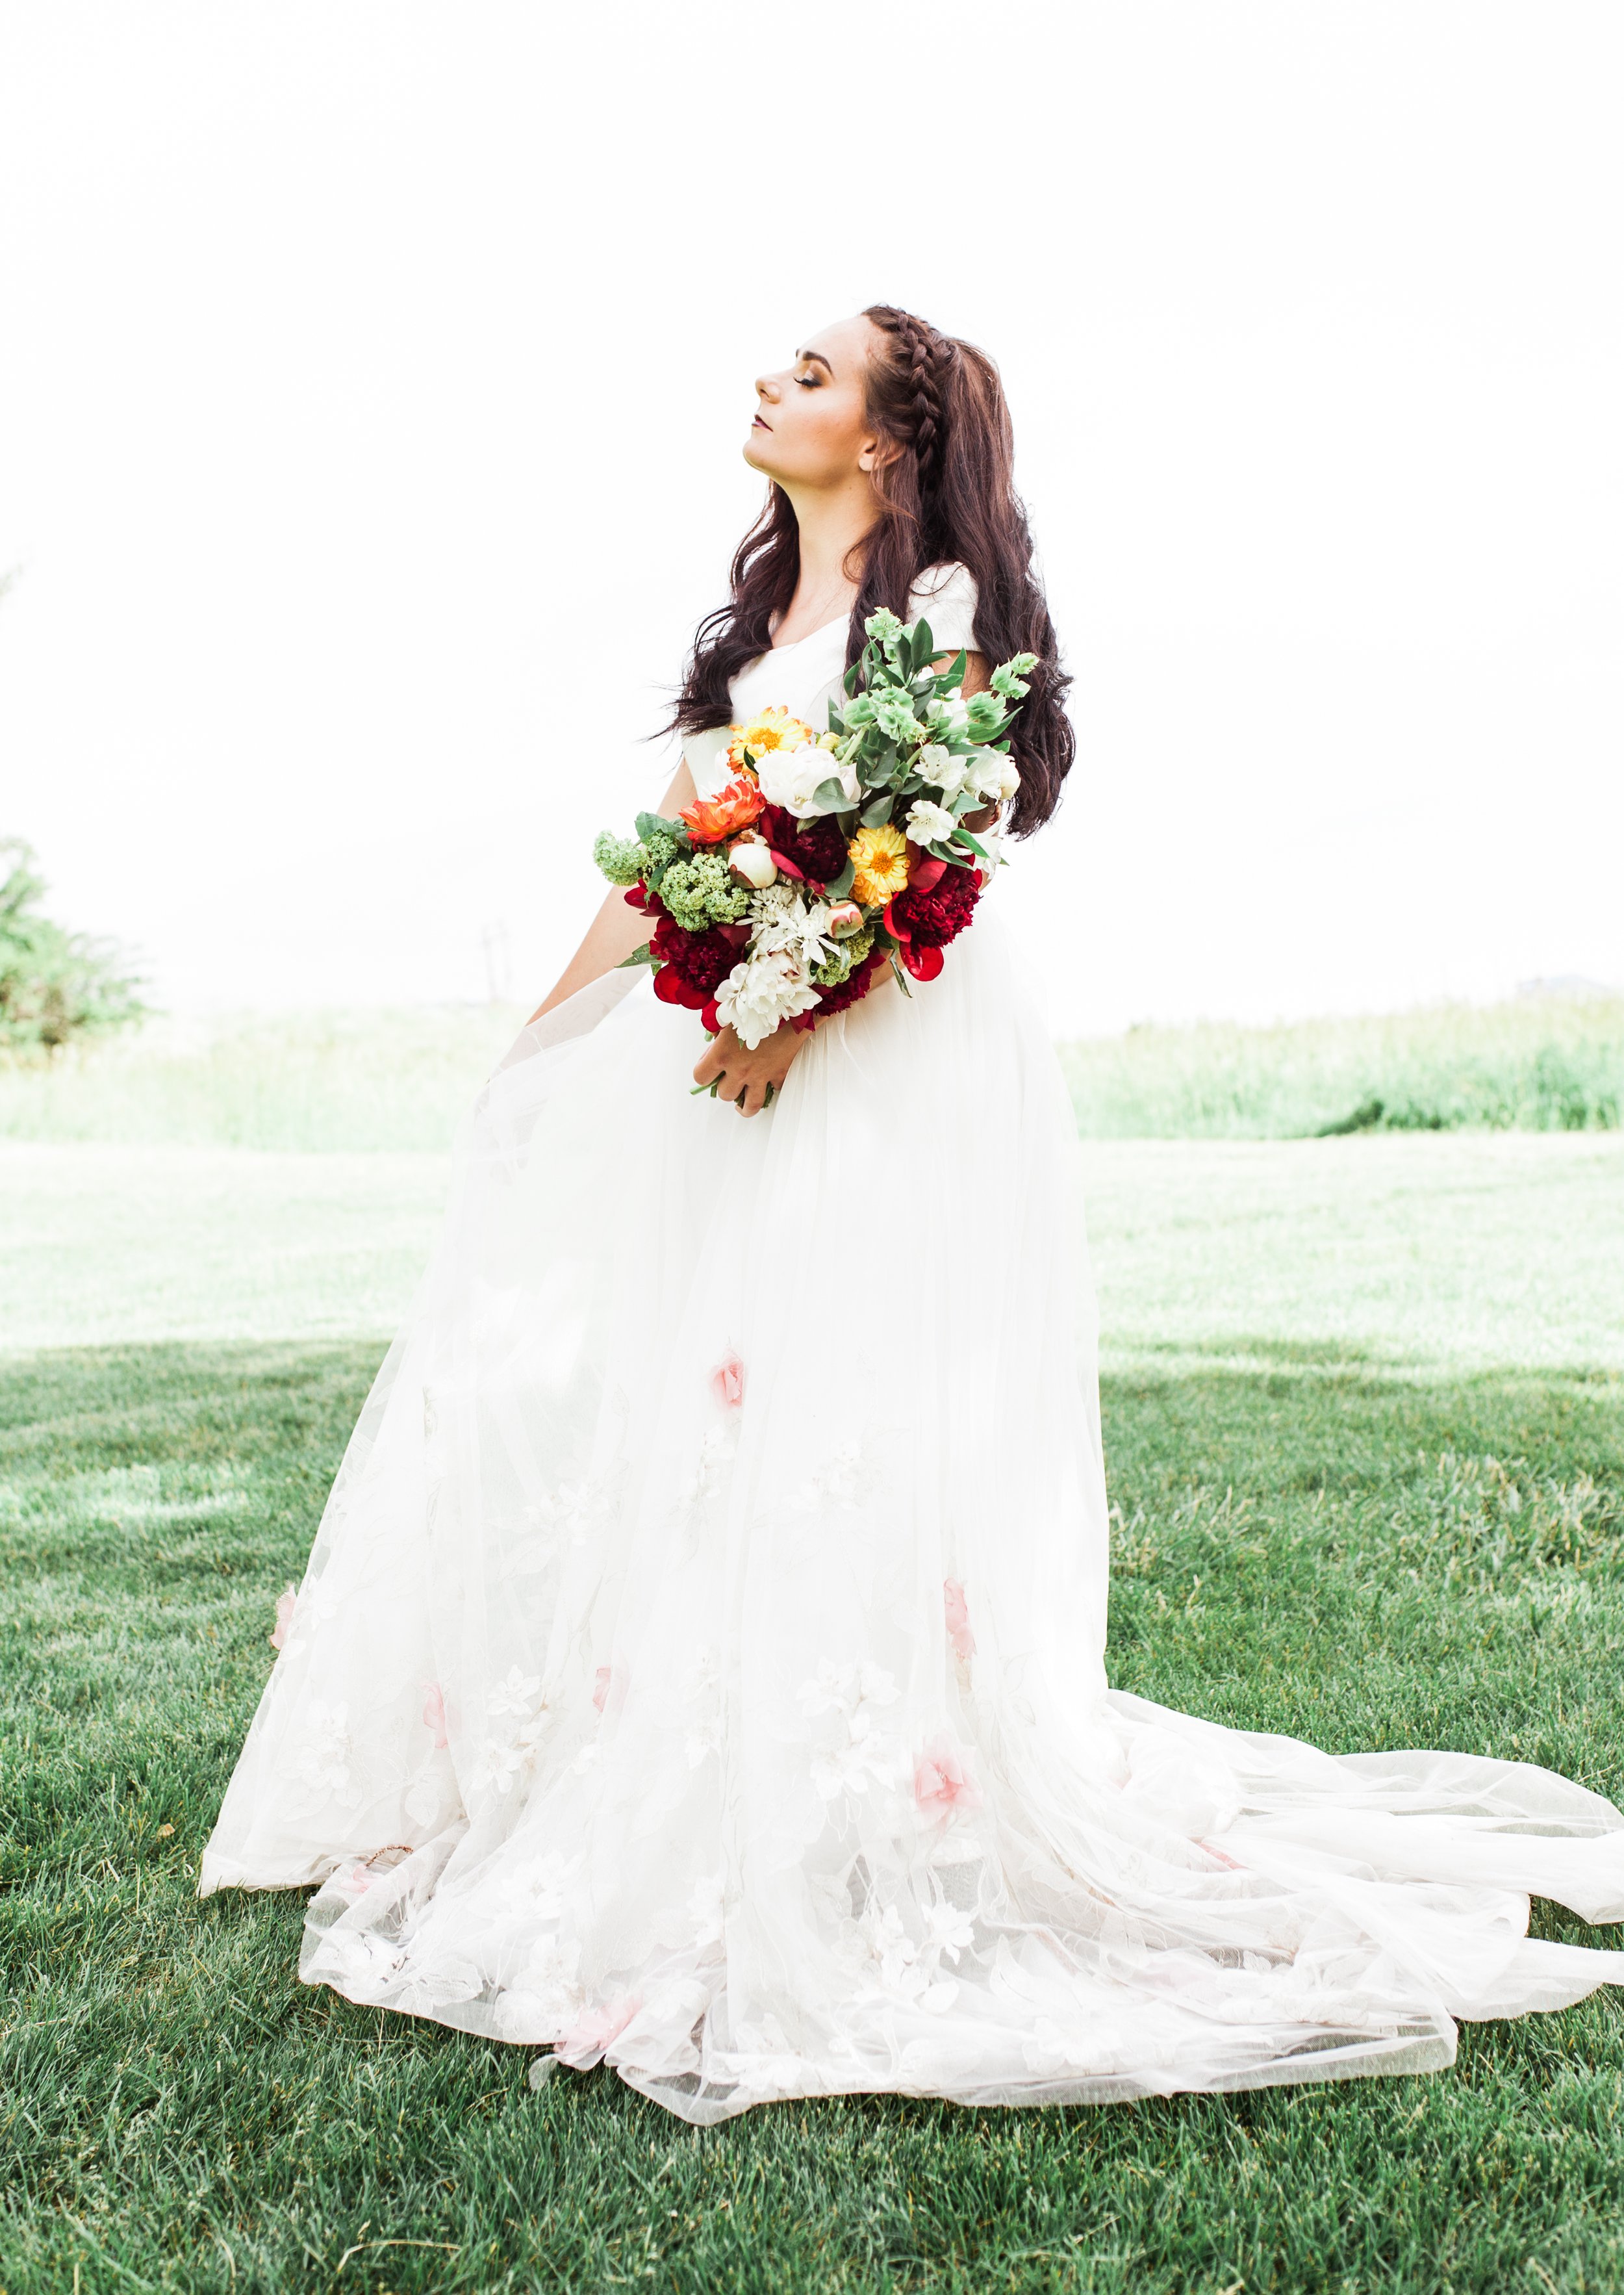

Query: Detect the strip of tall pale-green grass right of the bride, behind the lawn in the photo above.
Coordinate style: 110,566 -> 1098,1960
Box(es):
1059,996 -> 1624,1138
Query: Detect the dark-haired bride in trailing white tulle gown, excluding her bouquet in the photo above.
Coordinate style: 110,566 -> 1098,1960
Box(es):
202,305 -> 1624,2121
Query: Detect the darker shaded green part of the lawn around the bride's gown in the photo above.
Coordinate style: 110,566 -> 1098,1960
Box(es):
0,1333 -> 1624,2295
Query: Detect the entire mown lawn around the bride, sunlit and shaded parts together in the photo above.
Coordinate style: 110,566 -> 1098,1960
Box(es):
0,1014 -> 1624,2295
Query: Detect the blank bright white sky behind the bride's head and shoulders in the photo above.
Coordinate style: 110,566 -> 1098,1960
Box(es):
0,0 -> 1624,1031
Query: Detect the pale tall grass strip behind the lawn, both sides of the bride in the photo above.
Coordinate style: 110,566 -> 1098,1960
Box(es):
0,996 -> 1624,1150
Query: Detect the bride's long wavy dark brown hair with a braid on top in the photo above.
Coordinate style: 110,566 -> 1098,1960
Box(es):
672,303 -> 1076,836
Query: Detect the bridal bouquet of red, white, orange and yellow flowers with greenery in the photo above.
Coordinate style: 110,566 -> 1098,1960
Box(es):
594,613 -> 1037,1049
